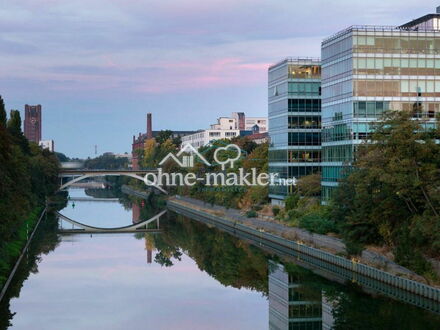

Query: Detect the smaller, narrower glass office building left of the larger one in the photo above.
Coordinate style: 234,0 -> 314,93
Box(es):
268,58 -> 321,204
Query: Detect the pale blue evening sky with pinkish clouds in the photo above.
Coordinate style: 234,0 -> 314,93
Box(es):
0,0 -> 440,158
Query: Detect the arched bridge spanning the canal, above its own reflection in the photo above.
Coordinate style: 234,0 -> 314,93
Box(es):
58,168 -> 164,194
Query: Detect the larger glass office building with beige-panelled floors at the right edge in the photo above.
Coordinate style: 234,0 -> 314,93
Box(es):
321,10 -> 440,202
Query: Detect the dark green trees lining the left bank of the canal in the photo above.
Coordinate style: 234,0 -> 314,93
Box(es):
0,97 -> 59,287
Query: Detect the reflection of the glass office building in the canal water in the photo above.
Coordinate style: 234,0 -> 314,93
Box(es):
269,261 -> 333,330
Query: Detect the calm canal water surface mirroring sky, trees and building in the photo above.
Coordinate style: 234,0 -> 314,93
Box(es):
0,189 -> 440,330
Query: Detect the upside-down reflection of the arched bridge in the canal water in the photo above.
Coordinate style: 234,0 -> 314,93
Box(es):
56,210 -> 167,233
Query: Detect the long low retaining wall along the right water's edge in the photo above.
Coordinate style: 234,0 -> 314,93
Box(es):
168,196 -> 440,313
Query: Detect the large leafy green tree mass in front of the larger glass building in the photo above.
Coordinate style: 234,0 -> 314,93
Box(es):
331,111 -> 440,266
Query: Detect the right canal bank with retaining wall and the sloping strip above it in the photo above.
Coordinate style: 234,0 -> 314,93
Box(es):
168,196 -> 440,312
